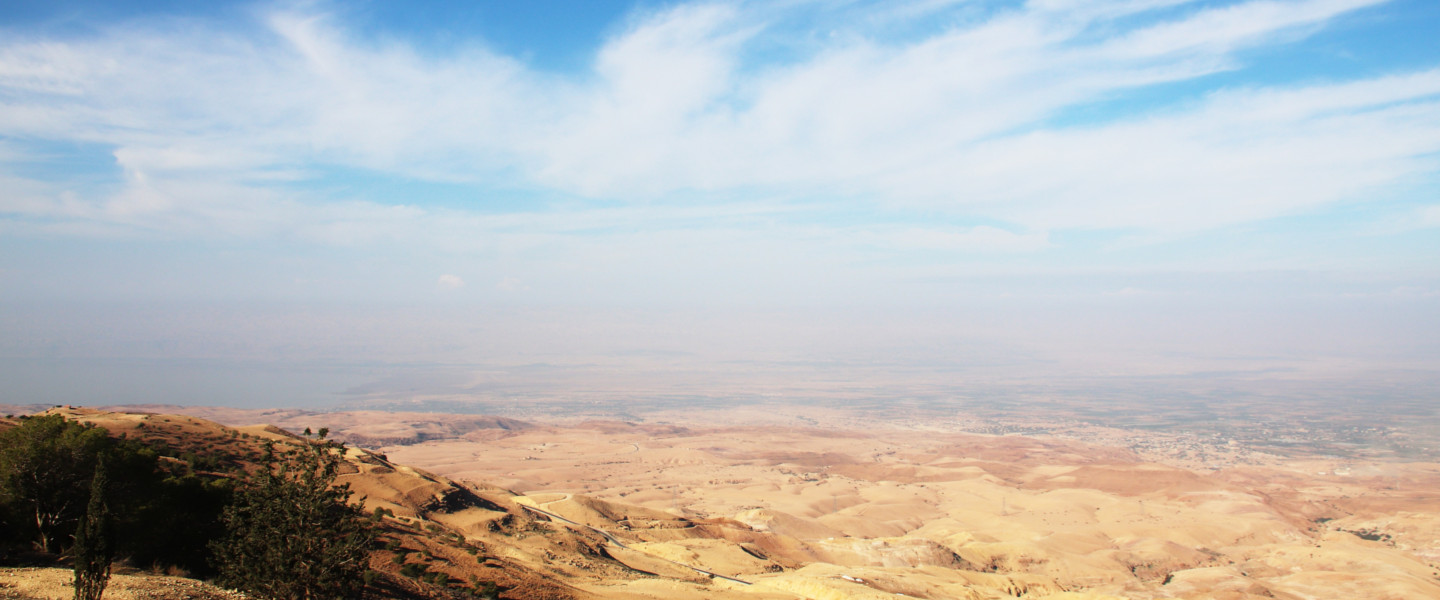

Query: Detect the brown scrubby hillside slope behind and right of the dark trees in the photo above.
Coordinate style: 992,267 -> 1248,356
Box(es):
23,407 -> 624,599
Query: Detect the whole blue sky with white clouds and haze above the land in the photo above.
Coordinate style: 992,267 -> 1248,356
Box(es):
0,0 -> 1440,406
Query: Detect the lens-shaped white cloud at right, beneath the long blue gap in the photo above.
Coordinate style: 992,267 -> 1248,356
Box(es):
915,72 -> 1440,232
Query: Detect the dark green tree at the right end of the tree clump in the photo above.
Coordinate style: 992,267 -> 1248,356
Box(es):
210,442 -> 374,600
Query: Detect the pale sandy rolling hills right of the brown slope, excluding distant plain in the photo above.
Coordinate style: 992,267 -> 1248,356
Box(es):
383,423 -> 1440,599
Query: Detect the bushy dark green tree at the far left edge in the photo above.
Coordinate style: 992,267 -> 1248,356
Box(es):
0,414 -> 109,553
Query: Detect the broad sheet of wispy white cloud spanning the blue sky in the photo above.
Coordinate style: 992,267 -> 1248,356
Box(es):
0,0 -> 1440,252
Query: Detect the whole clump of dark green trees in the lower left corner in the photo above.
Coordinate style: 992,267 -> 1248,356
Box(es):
0,414 -> 374,600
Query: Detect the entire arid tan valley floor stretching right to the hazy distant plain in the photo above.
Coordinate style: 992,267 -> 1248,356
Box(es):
5,404 -> 1440,600
